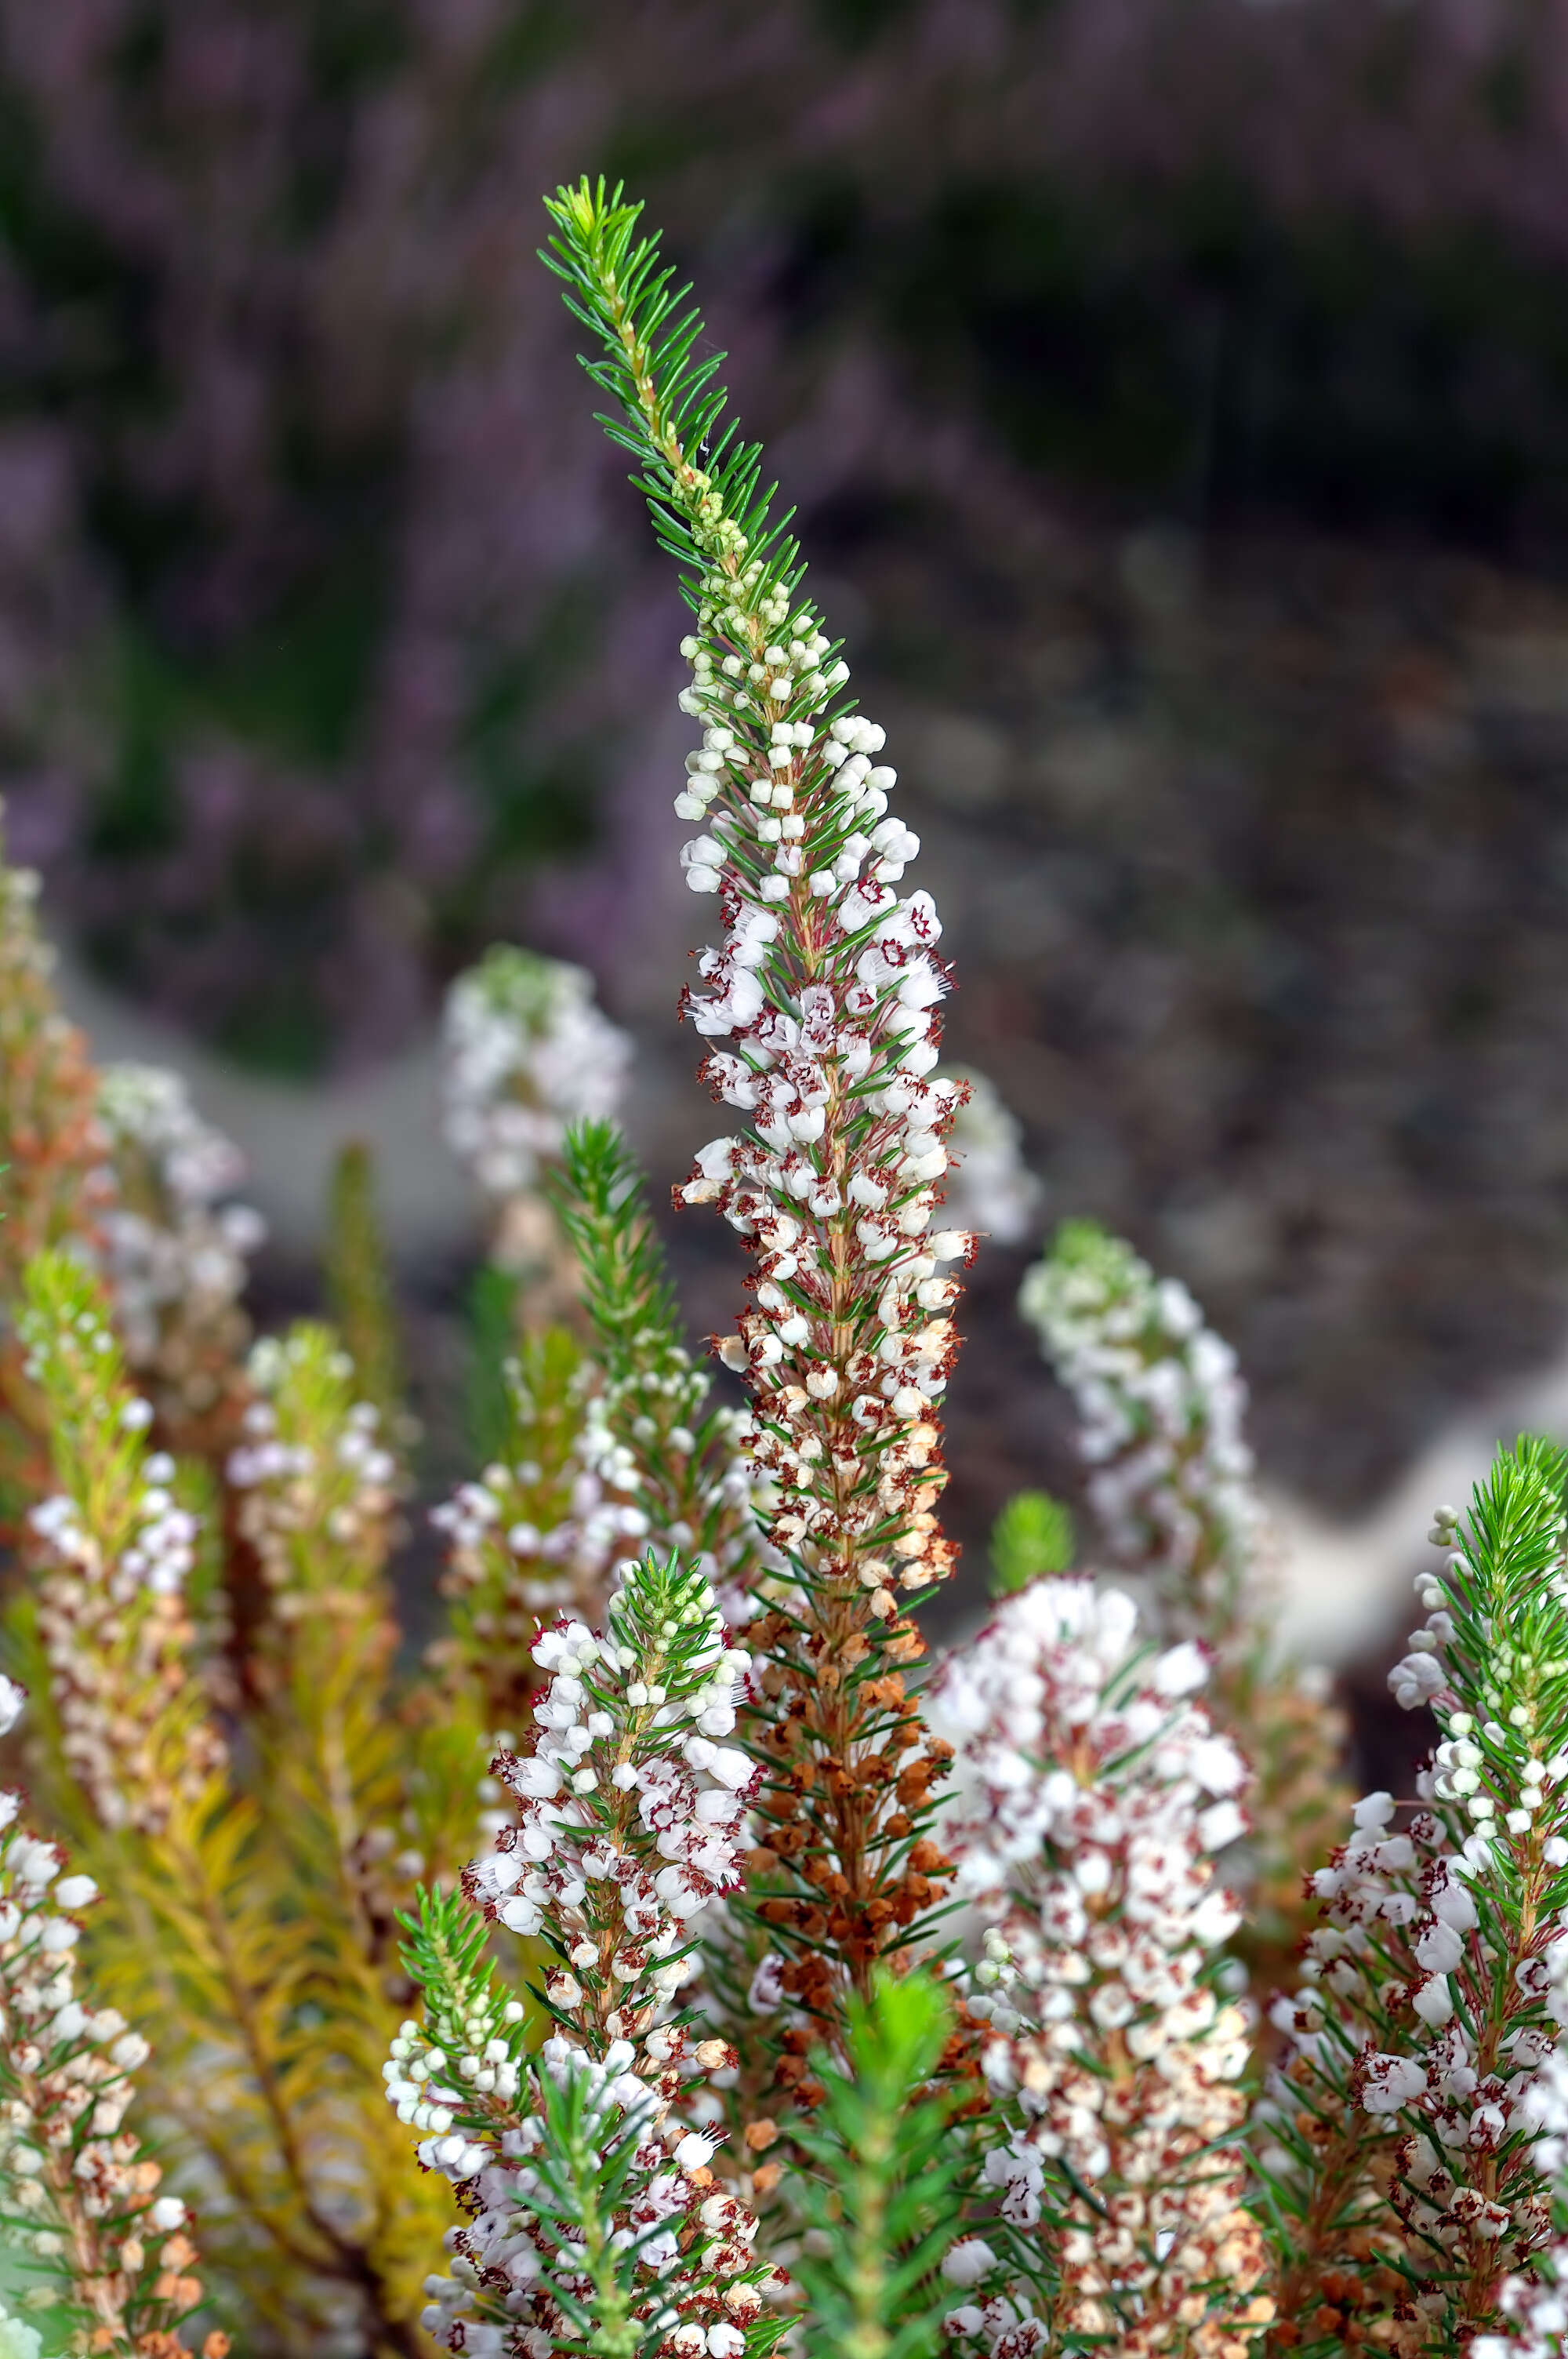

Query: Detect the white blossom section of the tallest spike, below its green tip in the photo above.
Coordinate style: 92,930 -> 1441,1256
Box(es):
677,609 -> 974,1618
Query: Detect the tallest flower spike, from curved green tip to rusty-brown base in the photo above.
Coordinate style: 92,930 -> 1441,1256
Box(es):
545,182 -> 971,2019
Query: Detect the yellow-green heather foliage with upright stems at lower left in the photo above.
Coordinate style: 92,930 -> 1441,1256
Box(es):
9,1255 -> 471,2352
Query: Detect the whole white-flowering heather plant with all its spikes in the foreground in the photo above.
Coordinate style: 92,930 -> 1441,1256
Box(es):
0,184 -> 1568,2359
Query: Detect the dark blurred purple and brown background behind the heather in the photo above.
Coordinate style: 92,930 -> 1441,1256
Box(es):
0,0 -> 1568,1698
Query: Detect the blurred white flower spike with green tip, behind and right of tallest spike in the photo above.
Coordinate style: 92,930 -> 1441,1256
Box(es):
1018,1222 -> 1264,1637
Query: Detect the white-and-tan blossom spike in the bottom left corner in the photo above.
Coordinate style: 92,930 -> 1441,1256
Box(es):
0,1677 -> 214,2359
